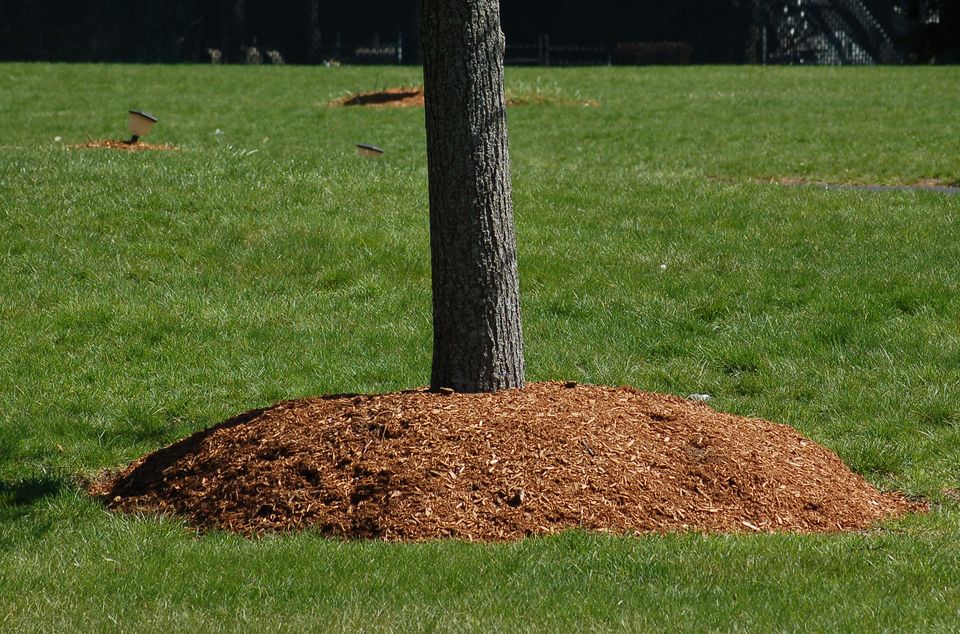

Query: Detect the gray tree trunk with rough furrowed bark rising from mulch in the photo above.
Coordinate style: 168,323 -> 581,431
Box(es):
420,0 -> 524,392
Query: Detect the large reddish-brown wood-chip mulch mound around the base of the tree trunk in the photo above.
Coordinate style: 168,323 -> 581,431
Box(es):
91,382 -> 927,541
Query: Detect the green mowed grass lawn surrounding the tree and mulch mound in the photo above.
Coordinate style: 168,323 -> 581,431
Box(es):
0,64 -> 960,632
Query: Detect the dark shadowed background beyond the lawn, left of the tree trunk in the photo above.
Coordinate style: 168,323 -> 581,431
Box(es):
0,0 -> 418,64
